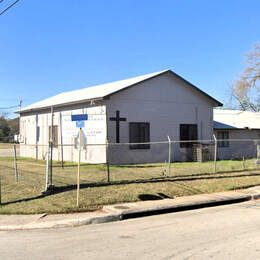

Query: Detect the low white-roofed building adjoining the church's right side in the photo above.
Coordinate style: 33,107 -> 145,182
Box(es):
214,109 -> 260,159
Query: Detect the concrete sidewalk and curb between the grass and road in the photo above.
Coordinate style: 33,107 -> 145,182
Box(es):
0,186 -> 260,230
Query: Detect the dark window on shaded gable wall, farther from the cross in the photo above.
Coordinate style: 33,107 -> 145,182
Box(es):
180,124 -> 198,147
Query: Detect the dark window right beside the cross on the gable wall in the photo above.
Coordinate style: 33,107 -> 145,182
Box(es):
129,123 -> 150,149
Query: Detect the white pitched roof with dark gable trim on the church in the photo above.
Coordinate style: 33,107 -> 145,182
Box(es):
21,70 -> 222,112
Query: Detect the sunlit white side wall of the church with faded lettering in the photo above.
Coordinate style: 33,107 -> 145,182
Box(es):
20,103 -> 107,163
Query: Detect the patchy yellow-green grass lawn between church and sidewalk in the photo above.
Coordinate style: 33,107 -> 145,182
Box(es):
0,157 -> 260,214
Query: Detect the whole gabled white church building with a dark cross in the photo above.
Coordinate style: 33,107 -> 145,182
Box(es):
20,70 -> 222,164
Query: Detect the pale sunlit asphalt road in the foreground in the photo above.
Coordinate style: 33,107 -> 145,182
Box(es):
0,201 -> 260,260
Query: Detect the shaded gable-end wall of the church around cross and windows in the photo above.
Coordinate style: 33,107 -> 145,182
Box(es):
107,74 -> 213,163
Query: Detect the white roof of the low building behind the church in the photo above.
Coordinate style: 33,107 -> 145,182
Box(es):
213,109 -> 260,130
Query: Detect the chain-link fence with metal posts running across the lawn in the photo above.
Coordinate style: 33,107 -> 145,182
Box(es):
0,139 -> 260,208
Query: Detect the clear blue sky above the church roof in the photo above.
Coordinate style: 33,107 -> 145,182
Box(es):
0,0 -> 260,115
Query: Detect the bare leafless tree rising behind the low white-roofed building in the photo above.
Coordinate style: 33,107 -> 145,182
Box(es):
231,43 -> 260,111
